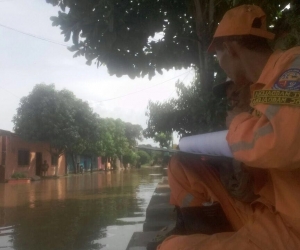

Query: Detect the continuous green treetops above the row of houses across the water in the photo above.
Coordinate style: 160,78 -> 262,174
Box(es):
13,84 -> 142,158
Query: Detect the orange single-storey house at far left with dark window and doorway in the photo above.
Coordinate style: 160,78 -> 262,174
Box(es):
0,129 -> 67,182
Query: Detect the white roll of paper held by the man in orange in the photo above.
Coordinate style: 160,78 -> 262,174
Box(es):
179,130 -> 233,158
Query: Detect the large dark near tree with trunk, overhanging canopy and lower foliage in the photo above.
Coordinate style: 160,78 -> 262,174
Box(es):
46,0 -> 297,137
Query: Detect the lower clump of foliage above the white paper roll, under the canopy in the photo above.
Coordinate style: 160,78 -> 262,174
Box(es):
144,79 -> 226,138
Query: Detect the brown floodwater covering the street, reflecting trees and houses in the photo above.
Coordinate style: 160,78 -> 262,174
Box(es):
0,167 -> 164,250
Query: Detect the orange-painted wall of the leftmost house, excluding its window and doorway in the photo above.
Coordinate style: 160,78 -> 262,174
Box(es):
0,135 -> 66,179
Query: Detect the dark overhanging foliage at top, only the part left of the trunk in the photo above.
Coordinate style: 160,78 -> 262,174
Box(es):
47,0 -> 202,78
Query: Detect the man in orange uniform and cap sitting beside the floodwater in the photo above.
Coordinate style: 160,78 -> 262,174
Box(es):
158,5 -> 300,250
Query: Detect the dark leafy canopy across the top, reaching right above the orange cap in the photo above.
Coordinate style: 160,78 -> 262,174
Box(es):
46,0 -> 291,83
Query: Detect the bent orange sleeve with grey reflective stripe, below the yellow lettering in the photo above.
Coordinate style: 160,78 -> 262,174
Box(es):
227,99 -> 300,169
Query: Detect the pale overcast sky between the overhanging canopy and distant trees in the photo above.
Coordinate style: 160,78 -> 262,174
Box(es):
0,0 -> 193,145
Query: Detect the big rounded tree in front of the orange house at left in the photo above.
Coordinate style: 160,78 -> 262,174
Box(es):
13,84 -> 98,173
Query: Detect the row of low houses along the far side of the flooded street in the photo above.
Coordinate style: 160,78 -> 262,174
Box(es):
0,129 -> 109,182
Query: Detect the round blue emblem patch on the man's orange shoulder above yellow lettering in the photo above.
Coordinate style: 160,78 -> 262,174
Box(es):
273,68 -> 300,90
